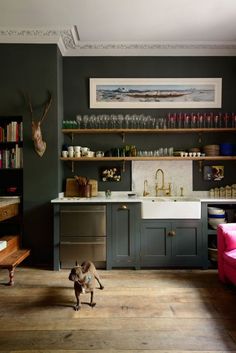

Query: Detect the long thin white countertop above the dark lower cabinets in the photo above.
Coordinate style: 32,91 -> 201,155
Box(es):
51,191 -> 236,203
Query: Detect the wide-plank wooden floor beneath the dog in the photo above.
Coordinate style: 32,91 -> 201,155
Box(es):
0,268 -> 236,353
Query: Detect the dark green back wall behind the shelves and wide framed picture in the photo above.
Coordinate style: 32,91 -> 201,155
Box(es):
63,57 -> 236,190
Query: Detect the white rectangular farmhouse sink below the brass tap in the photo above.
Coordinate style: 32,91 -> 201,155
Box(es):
141,197 -> 201,219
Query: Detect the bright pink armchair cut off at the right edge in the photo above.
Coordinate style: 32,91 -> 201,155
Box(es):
217,223 -> 236,285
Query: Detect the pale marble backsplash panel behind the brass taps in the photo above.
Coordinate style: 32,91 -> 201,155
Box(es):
132,161 -> 208,196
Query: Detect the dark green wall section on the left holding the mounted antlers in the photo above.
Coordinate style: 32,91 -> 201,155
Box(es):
0,44 -> 63,264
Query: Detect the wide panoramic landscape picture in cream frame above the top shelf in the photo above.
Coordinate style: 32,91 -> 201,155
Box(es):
89,78 -> 222,109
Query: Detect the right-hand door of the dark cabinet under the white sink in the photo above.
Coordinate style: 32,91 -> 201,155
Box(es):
170,220 -> 203,267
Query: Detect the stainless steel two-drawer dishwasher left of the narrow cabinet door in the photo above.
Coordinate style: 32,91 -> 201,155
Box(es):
60,205 -> 106,268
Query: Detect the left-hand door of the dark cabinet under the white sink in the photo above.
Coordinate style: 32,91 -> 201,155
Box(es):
140,220 -> 171,267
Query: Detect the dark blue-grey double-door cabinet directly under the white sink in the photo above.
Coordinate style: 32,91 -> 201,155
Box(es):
140,219 -> 207,267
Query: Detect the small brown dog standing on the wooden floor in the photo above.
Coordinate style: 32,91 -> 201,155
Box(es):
69,261 -> 104,311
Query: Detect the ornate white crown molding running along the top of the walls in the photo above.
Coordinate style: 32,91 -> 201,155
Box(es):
0,26 -> 236,56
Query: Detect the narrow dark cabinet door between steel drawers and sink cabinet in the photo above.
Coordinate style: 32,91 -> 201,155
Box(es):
111,203 -> 140,268
